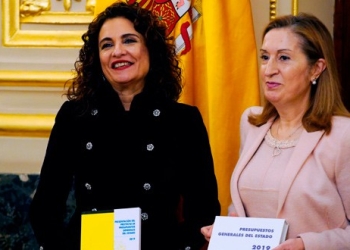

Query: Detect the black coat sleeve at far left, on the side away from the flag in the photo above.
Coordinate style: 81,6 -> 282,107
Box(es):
29,102 -> 77,249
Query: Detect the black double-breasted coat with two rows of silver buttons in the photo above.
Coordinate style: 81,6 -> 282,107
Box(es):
30,84 -> 220,250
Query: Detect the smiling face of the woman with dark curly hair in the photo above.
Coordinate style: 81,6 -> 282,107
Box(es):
99,17 -> 150,90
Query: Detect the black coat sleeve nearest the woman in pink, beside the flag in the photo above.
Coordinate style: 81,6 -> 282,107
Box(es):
176,107 -> 220,249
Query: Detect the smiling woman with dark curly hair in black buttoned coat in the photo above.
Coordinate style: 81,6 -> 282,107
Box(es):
30,3 -> 220,250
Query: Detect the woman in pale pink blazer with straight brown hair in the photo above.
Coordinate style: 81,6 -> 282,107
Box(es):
201,13 -> 350,250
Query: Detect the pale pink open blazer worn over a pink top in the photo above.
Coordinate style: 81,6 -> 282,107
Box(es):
229,107 -> 350,250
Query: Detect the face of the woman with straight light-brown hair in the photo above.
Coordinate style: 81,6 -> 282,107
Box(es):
260,28 -> 313,106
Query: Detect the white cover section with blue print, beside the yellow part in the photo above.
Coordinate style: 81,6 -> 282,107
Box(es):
114,207 -> 141,250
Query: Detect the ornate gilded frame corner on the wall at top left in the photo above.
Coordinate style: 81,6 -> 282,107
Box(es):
1,0 -> 93,47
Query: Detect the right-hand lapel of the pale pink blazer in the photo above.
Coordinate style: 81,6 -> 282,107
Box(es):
277,130 -> 324,215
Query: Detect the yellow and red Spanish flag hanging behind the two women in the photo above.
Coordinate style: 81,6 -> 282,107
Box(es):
95,0 -> 260,215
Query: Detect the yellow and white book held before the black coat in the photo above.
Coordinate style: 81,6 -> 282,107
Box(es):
80,207 -> 141,250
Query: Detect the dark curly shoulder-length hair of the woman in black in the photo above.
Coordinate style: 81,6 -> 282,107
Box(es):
66,2 -> 182,102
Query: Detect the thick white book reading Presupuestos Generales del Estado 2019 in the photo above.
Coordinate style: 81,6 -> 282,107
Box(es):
208,216 -> 288,250
